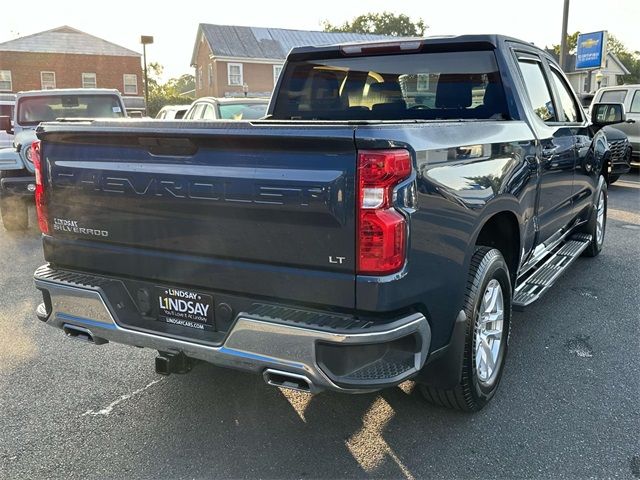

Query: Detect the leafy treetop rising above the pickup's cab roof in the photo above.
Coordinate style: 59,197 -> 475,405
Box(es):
322,12 -> 429,37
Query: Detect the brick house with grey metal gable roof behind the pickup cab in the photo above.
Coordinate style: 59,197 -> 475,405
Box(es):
191,23 -> 389,98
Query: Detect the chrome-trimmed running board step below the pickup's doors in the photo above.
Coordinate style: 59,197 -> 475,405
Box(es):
512,234 -> 591,311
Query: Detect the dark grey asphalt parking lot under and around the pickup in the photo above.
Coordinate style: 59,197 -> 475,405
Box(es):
0,170 -> 640,479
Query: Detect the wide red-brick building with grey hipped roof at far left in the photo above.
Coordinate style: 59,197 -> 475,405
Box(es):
0,26 -> 143,96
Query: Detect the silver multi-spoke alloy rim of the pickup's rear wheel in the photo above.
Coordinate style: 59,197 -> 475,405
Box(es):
475,279 -> 504,385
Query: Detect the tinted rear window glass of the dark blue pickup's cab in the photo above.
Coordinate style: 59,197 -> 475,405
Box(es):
273,51 -> 508,120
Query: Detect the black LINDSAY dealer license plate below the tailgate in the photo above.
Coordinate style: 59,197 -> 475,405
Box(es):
156,287 -> 213,330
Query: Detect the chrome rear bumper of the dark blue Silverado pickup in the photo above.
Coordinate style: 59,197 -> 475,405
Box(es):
34,267 -> 431,393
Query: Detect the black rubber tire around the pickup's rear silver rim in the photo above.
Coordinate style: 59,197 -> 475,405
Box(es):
419,247 -> 511,412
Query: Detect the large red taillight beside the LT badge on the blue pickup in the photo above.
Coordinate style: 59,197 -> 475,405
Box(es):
358,149 -> 411,275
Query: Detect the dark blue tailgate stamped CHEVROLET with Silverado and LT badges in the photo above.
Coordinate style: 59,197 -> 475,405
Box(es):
40,122 -> 356,308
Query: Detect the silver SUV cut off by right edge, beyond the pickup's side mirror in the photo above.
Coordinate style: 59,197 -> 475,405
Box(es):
593,84 -> 640,166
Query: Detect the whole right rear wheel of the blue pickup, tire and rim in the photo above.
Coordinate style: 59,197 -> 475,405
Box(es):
420,247 -> 511,411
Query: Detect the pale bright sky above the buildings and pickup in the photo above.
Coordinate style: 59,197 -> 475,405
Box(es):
0,0 -> 640,80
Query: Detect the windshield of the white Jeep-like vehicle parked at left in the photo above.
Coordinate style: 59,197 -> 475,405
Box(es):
18,95 -> 124,125
